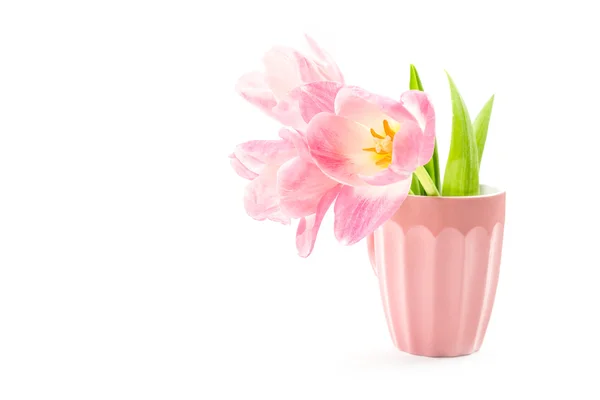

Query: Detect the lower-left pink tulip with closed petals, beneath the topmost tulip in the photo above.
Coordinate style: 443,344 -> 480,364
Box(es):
229,120 -> 342,257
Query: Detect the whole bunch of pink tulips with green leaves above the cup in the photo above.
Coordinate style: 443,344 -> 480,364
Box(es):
230,36 -> 494,257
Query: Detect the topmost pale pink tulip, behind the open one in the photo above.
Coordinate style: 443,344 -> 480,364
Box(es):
236,36 -> 344,131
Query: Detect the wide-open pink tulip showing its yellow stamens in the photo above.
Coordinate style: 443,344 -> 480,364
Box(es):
308,87 -> 435,244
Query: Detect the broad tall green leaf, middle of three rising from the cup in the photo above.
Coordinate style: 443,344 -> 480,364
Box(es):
442,72 -> 479,196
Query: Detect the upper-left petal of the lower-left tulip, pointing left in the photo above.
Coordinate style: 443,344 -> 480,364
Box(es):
234,140 -> 297,174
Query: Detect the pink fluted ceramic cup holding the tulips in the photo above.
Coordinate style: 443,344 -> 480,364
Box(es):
368,186 -> 505,357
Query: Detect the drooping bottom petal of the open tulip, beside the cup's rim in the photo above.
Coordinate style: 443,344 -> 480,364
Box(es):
334,179 -> 410,245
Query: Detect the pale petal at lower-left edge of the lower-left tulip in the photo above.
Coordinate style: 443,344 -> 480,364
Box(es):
244,166 -> 289,224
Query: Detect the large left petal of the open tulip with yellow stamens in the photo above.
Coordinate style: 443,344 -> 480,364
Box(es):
306,113 -> 380,185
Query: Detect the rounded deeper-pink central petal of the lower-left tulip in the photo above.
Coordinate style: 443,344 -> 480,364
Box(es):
277,157 -> 338,218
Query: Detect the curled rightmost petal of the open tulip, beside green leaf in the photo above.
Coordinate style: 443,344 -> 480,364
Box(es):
400,90 -> 435,165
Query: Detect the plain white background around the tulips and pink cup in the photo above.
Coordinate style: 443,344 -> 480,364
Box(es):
0,0 -> 600,400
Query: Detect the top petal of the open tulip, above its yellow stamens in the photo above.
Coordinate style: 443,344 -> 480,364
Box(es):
335,86 -> 414,130
